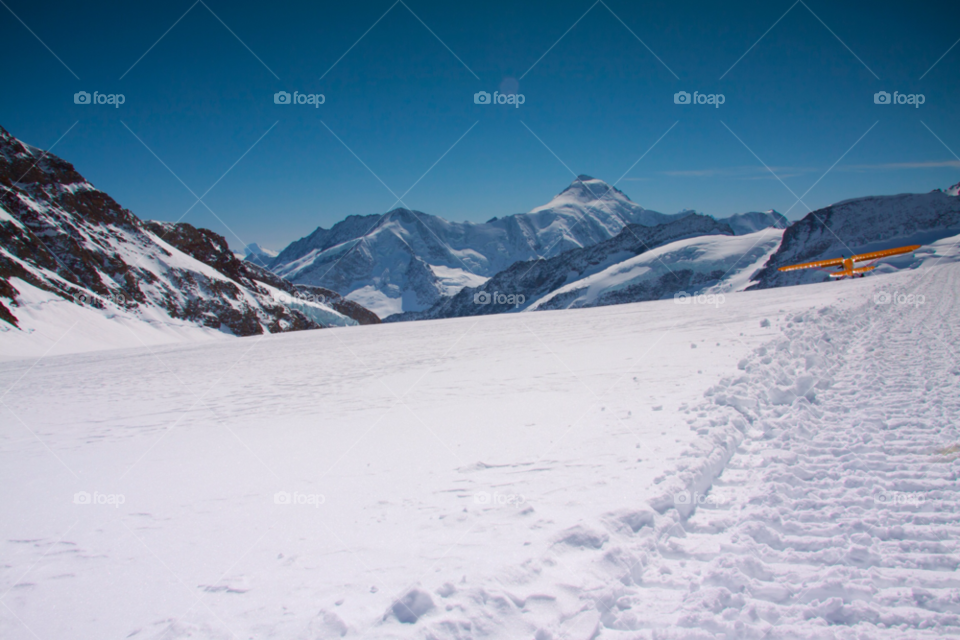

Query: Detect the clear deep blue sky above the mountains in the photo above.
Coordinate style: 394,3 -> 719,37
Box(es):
0,0 -> 960,249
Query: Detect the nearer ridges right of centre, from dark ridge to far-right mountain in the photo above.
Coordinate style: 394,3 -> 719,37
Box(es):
385,186 -> 960,322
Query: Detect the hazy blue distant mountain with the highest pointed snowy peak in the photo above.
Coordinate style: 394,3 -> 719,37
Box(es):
268,175 -> 685,317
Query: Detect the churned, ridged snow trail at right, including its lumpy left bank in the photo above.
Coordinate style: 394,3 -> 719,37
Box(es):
425,267 -> 960,640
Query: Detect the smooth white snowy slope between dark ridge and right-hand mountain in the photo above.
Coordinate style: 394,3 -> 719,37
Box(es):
527,229 -> 783,311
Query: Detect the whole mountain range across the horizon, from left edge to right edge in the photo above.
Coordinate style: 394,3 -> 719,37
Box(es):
0,119 -> 960,350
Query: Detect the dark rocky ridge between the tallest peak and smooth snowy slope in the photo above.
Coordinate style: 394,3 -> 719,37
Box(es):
386,213 -> 742,322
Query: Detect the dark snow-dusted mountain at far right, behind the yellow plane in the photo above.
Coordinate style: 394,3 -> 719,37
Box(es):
754,185 -> 960,289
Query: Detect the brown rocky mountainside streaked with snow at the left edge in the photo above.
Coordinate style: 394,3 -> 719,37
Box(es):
0,128 -> 376,356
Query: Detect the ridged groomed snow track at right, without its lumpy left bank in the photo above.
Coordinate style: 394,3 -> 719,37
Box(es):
624,269 -> 960,638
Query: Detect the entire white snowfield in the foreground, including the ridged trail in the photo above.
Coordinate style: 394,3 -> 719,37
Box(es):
0,256 -> 960,640
